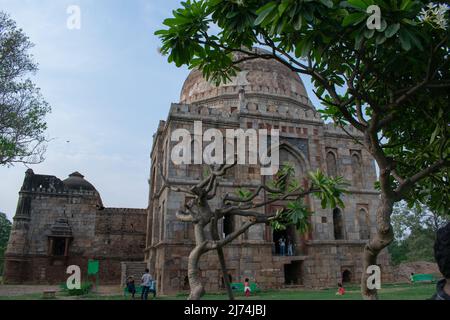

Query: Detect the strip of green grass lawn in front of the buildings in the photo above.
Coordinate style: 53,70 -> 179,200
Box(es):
0,284 -> 435,301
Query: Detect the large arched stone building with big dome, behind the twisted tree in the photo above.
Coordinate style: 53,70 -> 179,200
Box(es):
145,55 -> 392,293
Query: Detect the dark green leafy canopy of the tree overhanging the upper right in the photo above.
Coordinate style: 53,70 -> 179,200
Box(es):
156,0 -> 450,214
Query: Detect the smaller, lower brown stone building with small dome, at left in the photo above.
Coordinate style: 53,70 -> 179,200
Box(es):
4,170 -> 147,284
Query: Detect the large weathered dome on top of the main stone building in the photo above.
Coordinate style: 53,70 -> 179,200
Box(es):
180,49 -> 311,106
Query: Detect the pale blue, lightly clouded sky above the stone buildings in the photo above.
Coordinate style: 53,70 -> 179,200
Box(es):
0,0 -> 319,219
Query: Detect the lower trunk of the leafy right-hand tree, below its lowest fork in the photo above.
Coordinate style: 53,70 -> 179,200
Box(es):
361,195 -> 394,300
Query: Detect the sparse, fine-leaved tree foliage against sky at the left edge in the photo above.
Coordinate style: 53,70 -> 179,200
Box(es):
0,11 -> 50,165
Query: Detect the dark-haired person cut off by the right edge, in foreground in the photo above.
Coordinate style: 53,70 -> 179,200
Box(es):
431,222 -> 450,300
